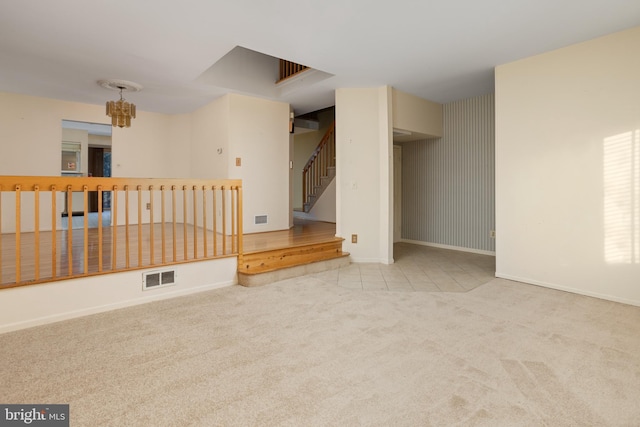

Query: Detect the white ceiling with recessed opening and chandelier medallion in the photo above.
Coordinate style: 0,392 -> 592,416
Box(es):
0,0 -> 640,114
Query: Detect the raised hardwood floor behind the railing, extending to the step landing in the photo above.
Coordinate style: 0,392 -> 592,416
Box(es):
0,217 -> 336,287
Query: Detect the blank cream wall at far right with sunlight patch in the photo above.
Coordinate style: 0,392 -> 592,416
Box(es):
496,28 -> 640,305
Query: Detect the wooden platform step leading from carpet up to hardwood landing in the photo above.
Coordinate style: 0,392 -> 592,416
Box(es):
238,238 -> 349,286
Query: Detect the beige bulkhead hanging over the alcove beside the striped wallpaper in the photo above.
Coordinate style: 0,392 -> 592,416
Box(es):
392,88 -> 442,140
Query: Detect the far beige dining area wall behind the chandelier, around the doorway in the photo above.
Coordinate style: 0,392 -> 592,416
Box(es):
0,93 -> 182,232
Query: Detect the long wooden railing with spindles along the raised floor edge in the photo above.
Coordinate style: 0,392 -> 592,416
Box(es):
0,176 -> 242,289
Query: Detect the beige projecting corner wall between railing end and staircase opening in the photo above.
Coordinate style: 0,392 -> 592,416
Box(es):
190,94 -> 291,233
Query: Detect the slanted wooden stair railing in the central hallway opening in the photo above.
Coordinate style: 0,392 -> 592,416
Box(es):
302,122 -> 336,212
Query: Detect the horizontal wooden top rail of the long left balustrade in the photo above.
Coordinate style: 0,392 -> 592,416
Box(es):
0,175 -> 242,191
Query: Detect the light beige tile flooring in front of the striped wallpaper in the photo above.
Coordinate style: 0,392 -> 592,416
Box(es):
314,243 -> 496,292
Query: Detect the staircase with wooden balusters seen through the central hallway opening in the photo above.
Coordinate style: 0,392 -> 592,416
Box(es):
302,122 -> 336,213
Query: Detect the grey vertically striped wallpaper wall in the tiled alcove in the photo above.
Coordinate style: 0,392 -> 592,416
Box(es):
400,94 -> 495,252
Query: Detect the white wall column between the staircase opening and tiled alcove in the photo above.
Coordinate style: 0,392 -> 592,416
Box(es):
336,86 -> 393,263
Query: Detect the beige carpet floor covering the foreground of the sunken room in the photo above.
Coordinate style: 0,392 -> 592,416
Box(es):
0,254 -> 640,426
